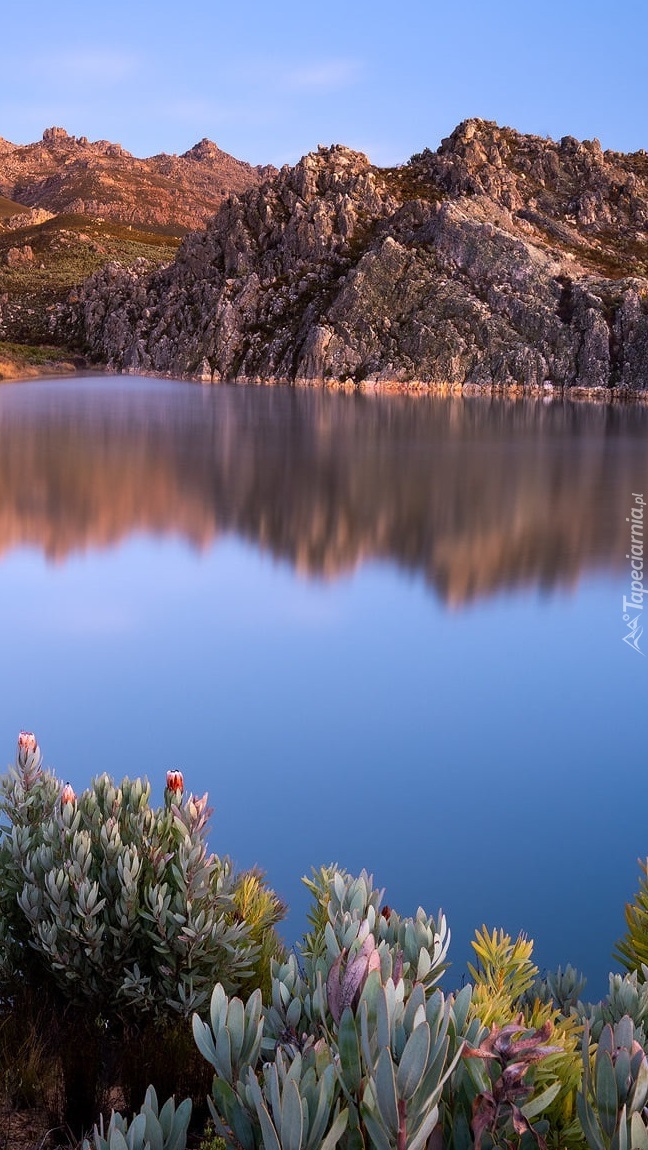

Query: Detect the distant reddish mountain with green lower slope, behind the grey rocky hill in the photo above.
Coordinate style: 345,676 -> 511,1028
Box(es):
0,128 -> 276,344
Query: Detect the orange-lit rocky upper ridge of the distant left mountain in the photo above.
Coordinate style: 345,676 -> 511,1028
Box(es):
0,128 -> 276,231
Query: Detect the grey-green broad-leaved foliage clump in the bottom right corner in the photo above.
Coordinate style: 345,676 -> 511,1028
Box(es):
578,1015 -> 648,1150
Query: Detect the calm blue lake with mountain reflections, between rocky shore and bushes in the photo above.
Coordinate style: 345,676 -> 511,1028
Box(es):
0,377 -> 648,997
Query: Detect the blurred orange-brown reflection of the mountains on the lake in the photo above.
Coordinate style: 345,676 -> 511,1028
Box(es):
0,378 -> 648,604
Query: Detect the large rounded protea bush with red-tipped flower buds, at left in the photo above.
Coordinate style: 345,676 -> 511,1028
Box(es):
0,731 -> 283,1129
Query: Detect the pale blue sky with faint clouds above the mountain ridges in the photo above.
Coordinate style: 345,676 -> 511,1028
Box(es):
0,0 -> 648,166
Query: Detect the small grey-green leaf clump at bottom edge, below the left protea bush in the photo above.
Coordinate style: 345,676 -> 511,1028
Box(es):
83,1087 -> 191,1150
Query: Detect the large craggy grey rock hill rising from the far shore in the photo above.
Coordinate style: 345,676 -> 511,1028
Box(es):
71,120 -> 648,392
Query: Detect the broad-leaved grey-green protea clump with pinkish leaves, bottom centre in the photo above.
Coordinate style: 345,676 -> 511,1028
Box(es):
193,867 -> 465,1150
